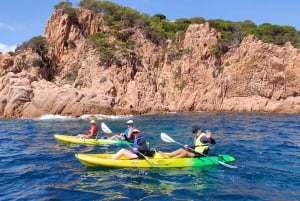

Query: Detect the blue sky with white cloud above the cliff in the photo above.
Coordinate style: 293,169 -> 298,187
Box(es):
0,0 -> 300,53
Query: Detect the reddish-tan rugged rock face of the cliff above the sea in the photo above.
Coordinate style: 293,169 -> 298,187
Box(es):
0,10 -> 300,117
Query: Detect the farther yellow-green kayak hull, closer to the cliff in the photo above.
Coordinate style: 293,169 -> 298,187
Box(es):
54,134 -> 132,145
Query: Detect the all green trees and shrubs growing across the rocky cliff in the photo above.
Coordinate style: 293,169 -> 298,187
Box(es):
12,0 -> 300,80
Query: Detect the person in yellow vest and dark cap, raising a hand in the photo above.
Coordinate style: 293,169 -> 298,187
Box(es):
161,128 -> 216,158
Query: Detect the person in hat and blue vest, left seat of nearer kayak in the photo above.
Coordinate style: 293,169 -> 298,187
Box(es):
112,129 -> 148,160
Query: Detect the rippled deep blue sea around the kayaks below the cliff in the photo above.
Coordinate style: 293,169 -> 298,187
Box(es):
0,112 -> 300,201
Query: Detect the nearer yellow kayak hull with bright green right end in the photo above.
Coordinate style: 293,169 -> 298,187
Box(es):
75,152 -> 235,168
